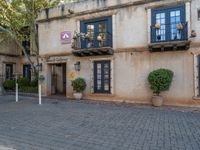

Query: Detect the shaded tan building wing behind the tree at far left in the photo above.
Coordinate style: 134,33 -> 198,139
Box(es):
0,38 -> 33,84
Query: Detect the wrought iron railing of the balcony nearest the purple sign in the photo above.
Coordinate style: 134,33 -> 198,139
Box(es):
72,32 -> 112,49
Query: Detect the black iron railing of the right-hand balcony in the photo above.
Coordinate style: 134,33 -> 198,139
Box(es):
151,22 -> 188,43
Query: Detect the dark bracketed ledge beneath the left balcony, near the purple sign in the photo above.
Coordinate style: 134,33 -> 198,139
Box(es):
72,47 -> 114,57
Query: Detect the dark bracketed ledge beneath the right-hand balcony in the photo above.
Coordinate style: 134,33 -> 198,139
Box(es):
148,40 -> 191,52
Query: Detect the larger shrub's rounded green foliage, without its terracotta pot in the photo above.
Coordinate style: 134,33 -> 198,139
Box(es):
148,68 -> 174,95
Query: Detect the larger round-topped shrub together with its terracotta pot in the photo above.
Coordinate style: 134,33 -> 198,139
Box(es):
148,68 -> 174,106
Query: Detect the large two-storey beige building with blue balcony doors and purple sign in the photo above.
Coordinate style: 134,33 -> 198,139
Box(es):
37,0 -> 200,106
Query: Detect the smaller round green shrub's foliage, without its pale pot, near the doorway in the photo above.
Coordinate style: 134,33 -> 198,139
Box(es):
72,78 -> 86,92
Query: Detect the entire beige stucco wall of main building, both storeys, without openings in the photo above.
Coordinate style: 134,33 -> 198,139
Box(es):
38,0 -> 200,105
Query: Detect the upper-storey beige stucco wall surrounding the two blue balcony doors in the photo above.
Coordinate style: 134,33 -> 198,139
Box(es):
38,0 -> 200,55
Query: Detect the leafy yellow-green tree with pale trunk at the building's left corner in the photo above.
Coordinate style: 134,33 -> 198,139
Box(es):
0,0 -> 59,77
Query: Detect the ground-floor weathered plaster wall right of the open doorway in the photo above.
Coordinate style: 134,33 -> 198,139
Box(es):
61,51 -> 194,105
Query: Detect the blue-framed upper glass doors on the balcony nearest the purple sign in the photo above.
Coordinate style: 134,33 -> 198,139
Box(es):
80,17 -> 112,48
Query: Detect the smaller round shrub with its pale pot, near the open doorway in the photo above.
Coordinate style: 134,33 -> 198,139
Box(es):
72,78 -> 86,100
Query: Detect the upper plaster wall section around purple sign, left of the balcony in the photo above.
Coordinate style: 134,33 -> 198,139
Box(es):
39,19 -> 76,55
